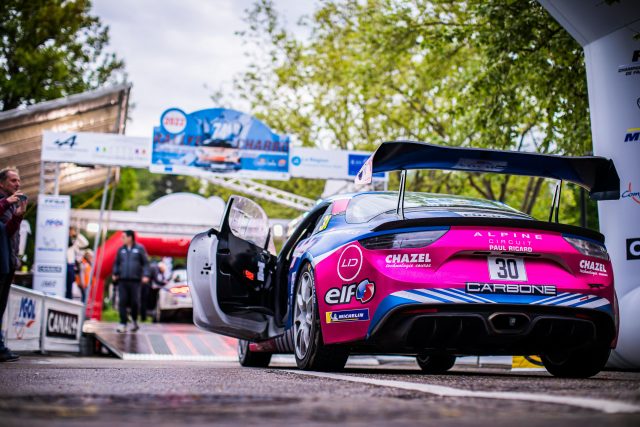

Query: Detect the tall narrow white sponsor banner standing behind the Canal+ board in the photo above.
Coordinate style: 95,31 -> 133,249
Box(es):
33,194 -> 71,296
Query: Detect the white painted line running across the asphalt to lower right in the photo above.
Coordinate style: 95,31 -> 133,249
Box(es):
285,370 -> 640,414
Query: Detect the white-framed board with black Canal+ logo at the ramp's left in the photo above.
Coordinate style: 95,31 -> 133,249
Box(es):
42,297 -> 83,352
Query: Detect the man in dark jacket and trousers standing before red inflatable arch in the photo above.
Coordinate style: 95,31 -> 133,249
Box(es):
112,230 -> 149,332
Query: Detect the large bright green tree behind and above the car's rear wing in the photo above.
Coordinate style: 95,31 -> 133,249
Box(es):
236,0 -> 591,227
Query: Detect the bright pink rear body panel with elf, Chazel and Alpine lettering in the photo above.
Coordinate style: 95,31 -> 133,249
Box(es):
315,226 -> 614,344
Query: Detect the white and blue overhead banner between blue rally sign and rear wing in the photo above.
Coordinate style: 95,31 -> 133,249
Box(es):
289,147 -> 385,181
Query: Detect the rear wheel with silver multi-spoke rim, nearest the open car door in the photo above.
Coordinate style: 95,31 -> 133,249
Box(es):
293,264 -> 349,371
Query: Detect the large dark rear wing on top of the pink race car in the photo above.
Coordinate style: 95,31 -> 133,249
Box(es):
355,141 -> 620,200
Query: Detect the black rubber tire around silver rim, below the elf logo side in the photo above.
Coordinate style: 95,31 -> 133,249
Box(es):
293,263 -> 349,372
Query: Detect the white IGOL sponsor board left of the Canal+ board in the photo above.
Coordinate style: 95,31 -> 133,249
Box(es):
2,285 -> 44,351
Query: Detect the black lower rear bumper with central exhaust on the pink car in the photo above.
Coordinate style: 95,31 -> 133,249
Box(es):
366,304 -> 616,355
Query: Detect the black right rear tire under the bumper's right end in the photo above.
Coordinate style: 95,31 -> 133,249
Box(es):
541,344 -> 611,378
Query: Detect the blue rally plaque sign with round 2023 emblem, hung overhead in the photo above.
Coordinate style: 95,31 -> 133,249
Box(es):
150,108 -> 289,180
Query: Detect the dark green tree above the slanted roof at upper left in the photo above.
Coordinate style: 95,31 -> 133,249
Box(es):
0,0 -> 125,111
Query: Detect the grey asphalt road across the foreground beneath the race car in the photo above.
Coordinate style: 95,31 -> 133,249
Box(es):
0,356 -> 640,427
